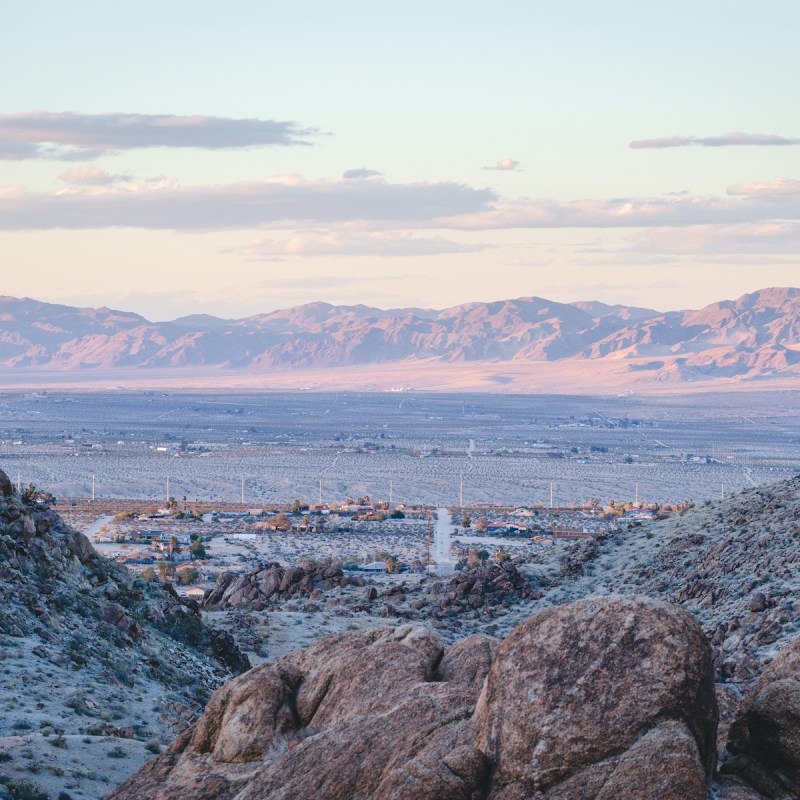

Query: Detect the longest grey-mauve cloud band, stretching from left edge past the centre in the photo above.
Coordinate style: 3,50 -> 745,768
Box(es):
0,175 -> 496,231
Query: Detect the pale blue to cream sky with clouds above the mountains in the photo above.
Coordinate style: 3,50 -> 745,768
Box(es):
0,0 -> 800,320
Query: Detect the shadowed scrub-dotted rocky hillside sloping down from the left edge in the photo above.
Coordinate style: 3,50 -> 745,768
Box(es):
0,471 -> 249,800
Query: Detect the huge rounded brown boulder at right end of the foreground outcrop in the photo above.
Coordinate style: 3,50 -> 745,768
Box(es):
475,597 -> 717,800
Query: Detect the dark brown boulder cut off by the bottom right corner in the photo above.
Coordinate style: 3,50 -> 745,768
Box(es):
722,639 -> 800,798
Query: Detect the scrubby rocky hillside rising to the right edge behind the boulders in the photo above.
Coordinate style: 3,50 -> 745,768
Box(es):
527,477 -> 800,684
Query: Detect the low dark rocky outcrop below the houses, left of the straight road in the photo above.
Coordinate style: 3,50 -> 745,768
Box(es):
203,563 -> 347,611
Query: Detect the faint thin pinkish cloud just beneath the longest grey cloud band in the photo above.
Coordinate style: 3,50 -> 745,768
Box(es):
239,231 -> 487,261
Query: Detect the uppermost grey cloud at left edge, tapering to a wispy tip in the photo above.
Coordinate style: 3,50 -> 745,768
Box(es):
0,111 -> 318,161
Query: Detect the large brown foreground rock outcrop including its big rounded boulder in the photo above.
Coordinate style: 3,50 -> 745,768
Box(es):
109,597 -> 716,800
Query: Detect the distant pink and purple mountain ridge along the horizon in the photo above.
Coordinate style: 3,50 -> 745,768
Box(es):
0,288 -> 800,380
